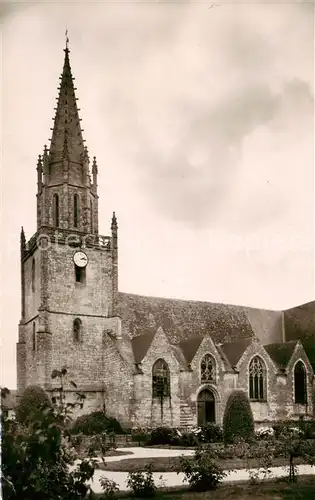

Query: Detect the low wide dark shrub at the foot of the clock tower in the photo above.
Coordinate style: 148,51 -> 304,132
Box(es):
71,411 -> 125,436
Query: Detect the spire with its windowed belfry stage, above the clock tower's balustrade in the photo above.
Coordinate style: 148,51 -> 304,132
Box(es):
37,45 -> 98,234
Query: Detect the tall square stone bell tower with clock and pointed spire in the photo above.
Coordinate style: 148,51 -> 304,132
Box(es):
17,38 -> 121,399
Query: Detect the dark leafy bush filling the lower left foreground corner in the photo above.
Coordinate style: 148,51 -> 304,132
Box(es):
1,369 -> 94,500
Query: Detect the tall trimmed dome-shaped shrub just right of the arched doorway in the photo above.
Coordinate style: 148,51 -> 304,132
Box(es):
223,391 -> 254,443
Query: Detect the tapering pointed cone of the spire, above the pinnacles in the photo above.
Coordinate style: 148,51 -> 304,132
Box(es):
49,47 -> 85,166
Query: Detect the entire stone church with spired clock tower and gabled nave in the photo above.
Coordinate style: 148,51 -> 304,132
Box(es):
17,47 -> 315,428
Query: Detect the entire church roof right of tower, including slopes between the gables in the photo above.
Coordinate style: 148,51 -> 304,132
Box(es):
118,292 -> 315,369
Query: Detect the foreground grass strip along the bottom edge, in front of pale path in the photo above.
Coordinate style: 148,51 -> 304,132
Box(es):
91,476 -> 315,500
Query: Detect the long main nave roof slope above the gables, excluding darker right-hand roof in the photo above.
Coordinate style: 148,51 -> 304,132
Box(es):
118,292 -> 282,344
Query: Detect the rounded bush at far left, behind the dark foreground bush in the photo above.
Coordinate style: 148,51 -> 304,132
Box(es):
15,385 -> 51,423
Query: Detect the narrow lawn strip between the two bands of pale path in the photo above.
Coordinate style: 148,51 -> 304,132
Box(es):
100,457 -> 306,470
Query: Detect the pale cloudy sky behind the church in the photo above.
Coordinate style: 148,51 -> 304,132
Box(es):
0,0 -> 315,388
